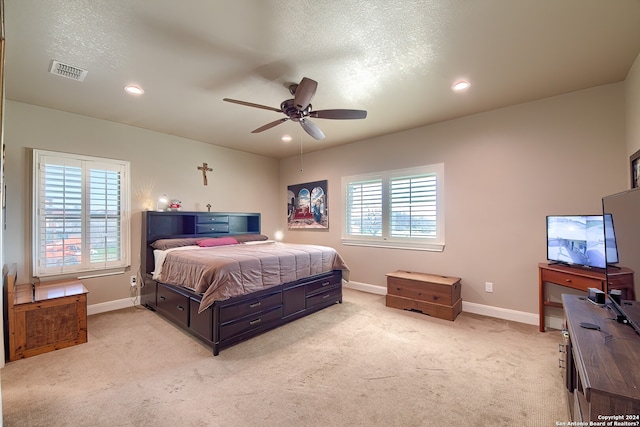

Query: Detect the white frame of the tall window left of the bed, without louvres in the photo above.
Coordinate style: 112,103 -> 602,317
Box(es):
32,149 -> 131,277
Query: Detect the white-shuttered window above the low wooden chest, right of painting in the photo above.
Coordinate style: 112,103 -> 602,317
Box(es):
342,164 -> 444,251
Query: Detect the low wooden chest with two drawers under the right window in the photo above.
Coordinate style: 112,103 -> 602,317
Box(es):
386,270 -> 462,320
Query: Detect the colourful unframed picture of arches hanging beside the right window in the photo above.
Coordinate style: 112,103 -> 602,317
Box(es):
287,179 -> 329,230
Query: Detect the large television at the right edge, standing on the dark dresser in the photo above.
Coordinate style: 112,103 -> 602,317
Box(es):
602,188 -> 640,334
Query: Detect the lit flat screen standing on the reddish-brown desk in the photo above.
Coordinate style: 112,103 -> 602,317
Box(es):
547,215 -> 618,269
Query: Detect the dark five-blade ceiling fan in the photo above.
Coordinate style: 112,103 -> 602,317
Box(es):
223,77 -> 367,140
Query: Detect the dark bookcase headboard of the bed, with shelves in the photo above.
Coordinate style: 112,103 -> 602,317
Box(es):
140,211 -> 260,277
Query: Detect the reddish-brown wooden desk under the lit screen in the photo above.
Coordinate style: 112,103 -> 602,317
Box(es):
538,262 -> 635,332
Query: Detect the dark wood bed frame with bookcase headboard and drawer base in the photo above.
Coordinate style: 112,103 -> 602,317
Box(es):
140,211 -> 342,356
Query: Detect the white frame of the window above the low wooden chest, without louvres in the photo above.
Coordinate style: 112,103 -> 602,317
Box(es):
341,163 -> 445,252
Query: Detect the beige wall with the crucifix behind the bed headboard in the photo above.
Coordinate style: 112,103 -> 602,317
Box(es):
5,101 -> 282,305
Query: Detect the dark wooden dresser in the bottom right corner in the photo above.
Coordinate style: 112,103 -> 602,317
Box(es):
561,294 -> 640,425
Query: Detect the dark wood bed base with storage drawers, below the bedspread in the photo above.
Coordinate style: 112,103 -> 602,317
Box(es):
142,270 -> 342,356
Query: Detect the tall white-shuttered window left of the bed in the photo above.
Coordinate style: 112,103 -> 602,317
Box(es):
33,150 -> 130,277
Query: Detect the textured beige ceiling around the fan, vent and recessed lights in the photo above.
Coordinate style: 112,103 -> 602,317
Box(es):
5,0 -> 640,158
